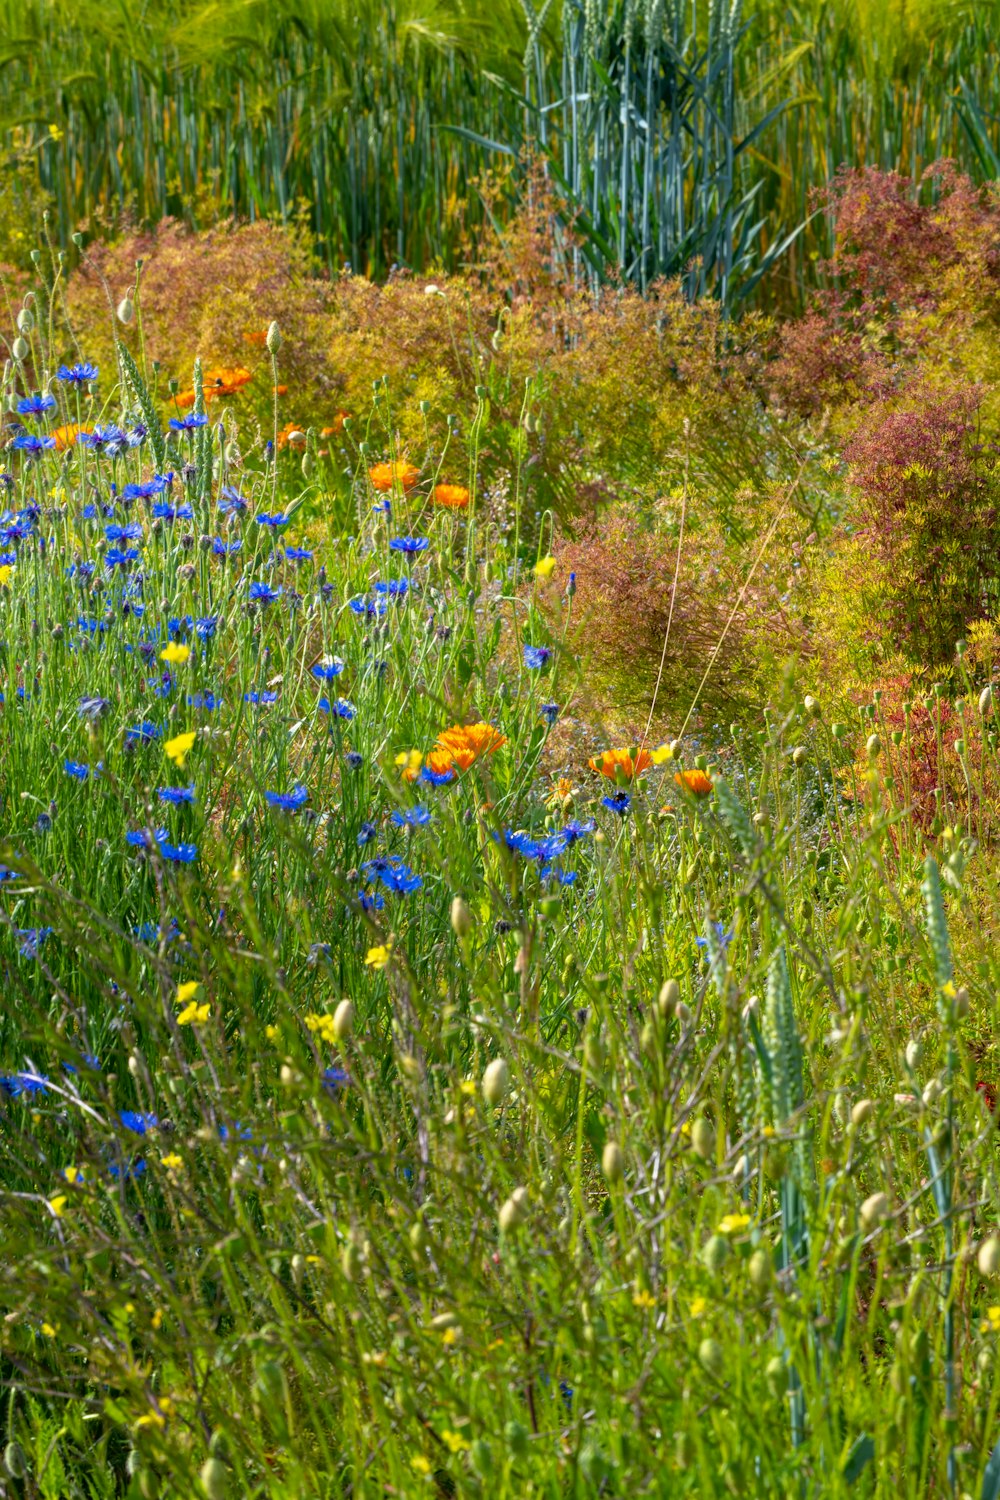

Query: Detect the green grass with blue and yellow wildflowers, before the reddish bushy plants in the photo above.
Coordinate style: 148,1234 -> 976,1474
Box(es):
0,264 -> 1000,1500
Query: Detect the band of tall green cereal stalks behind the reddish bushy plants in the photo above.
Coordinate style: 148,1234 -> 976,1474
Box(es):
0,0 -> 1000,302
